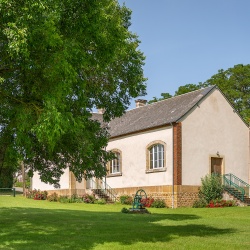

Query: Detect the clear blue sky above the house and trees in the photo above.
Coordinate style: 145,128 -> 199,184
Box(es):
119,0 -> 250,108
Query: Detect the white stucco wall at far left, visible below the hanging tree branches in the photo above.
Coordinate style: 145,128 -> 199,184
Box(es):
32,168 -> 69,190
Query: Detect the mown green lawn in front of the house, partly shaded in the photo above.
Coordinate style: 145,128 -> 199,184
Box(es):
0,196 -> 250,250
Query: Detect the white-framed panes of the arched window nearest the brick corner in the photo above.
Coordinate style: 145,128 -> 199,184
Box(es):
149,144 -> 164,169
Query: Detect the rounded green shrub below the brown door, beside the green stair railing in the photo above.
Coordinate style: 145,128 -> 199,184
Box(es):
199,174 -> 223,203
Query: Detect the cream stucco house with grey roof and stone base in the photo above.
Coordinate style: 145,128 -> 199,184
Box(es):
33,86 -> 249,207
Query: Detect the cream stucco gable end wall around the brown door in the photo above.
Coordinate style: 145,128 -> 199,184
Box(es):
182,90 -> 249,185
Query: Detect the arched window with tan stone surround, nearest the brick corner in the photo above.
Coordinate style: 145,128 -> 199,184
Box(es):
146,140 -> 166,173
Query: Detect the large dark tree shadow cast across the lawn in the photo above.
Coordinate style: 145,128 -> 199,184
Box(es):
0,208 -> 235,250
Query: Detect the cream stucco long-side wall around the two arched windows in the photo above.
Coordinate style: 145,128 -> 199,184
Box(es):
107,127 -> 173,188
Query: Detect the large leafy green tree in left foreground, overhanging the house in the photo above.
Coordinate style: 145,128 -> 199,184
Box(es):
0,0 -> 146,185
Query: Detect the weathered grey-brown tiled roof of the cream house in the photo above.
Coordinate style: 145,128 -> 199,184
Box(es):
93,86 -> 216,138
